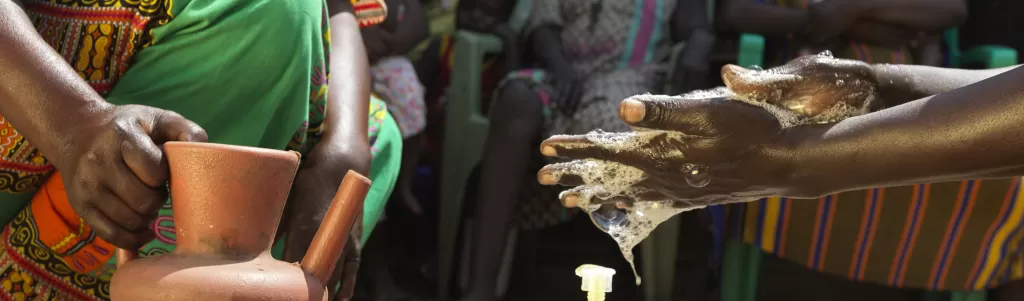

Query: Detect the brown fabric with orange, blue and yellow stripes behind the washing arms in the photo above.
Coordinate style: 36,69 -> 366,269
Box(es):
730,1 -> 1024,291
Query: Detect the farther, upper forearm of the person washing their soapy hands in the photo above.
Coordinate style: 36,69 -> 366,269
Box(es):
871,63 -> 1017,106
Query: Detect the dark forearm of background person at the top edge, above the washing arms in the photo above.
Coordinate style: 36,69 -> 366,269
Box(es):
850,0 -> 967,32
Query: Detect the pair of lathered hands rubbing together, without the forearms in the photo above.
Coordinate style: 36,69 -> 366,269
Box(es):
538,52 -> 878,208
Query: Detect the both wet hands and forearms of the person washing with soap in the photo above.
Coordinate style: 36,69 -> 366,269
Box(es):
538,54 -> 1024,207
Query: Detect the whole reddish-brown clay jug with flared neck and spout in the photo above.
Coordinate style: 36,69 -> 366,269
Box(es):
111,142 -> 370,301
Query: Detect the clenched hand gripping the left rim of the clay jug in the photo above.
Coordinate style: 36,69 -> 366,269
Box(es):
57,105 -> 207,250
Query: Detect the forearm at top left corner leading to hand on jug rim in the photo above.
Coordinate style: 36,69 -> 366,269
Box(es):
0,0 -> 111,164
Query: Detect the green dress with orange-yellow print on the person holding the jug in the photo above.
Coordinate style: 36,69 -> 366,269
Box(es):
0,0 -> 401,300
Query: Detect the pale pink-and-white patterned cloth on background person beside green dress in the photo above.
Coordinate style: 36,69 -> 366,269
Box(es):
370,56 -> 427,138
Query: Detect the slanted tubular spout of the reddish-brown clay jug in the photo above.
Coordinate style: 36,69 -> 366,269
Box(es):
300,170 -> 371,285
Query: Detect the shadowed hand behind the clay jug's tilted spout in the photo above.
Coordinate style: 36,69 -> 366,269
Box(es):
283,137 -> 372,297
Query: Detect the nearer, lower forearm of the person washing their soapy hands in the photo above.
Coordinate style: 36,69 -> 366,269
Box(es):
785,69 -> 1024,195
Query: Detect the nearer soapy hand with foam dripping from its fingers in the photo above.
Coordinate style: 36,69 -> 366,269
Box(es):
538,95 -> 811,207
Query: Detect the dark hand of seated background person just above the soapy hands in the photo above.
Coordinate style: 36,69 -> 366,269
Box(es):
805,0 -> 865,45
